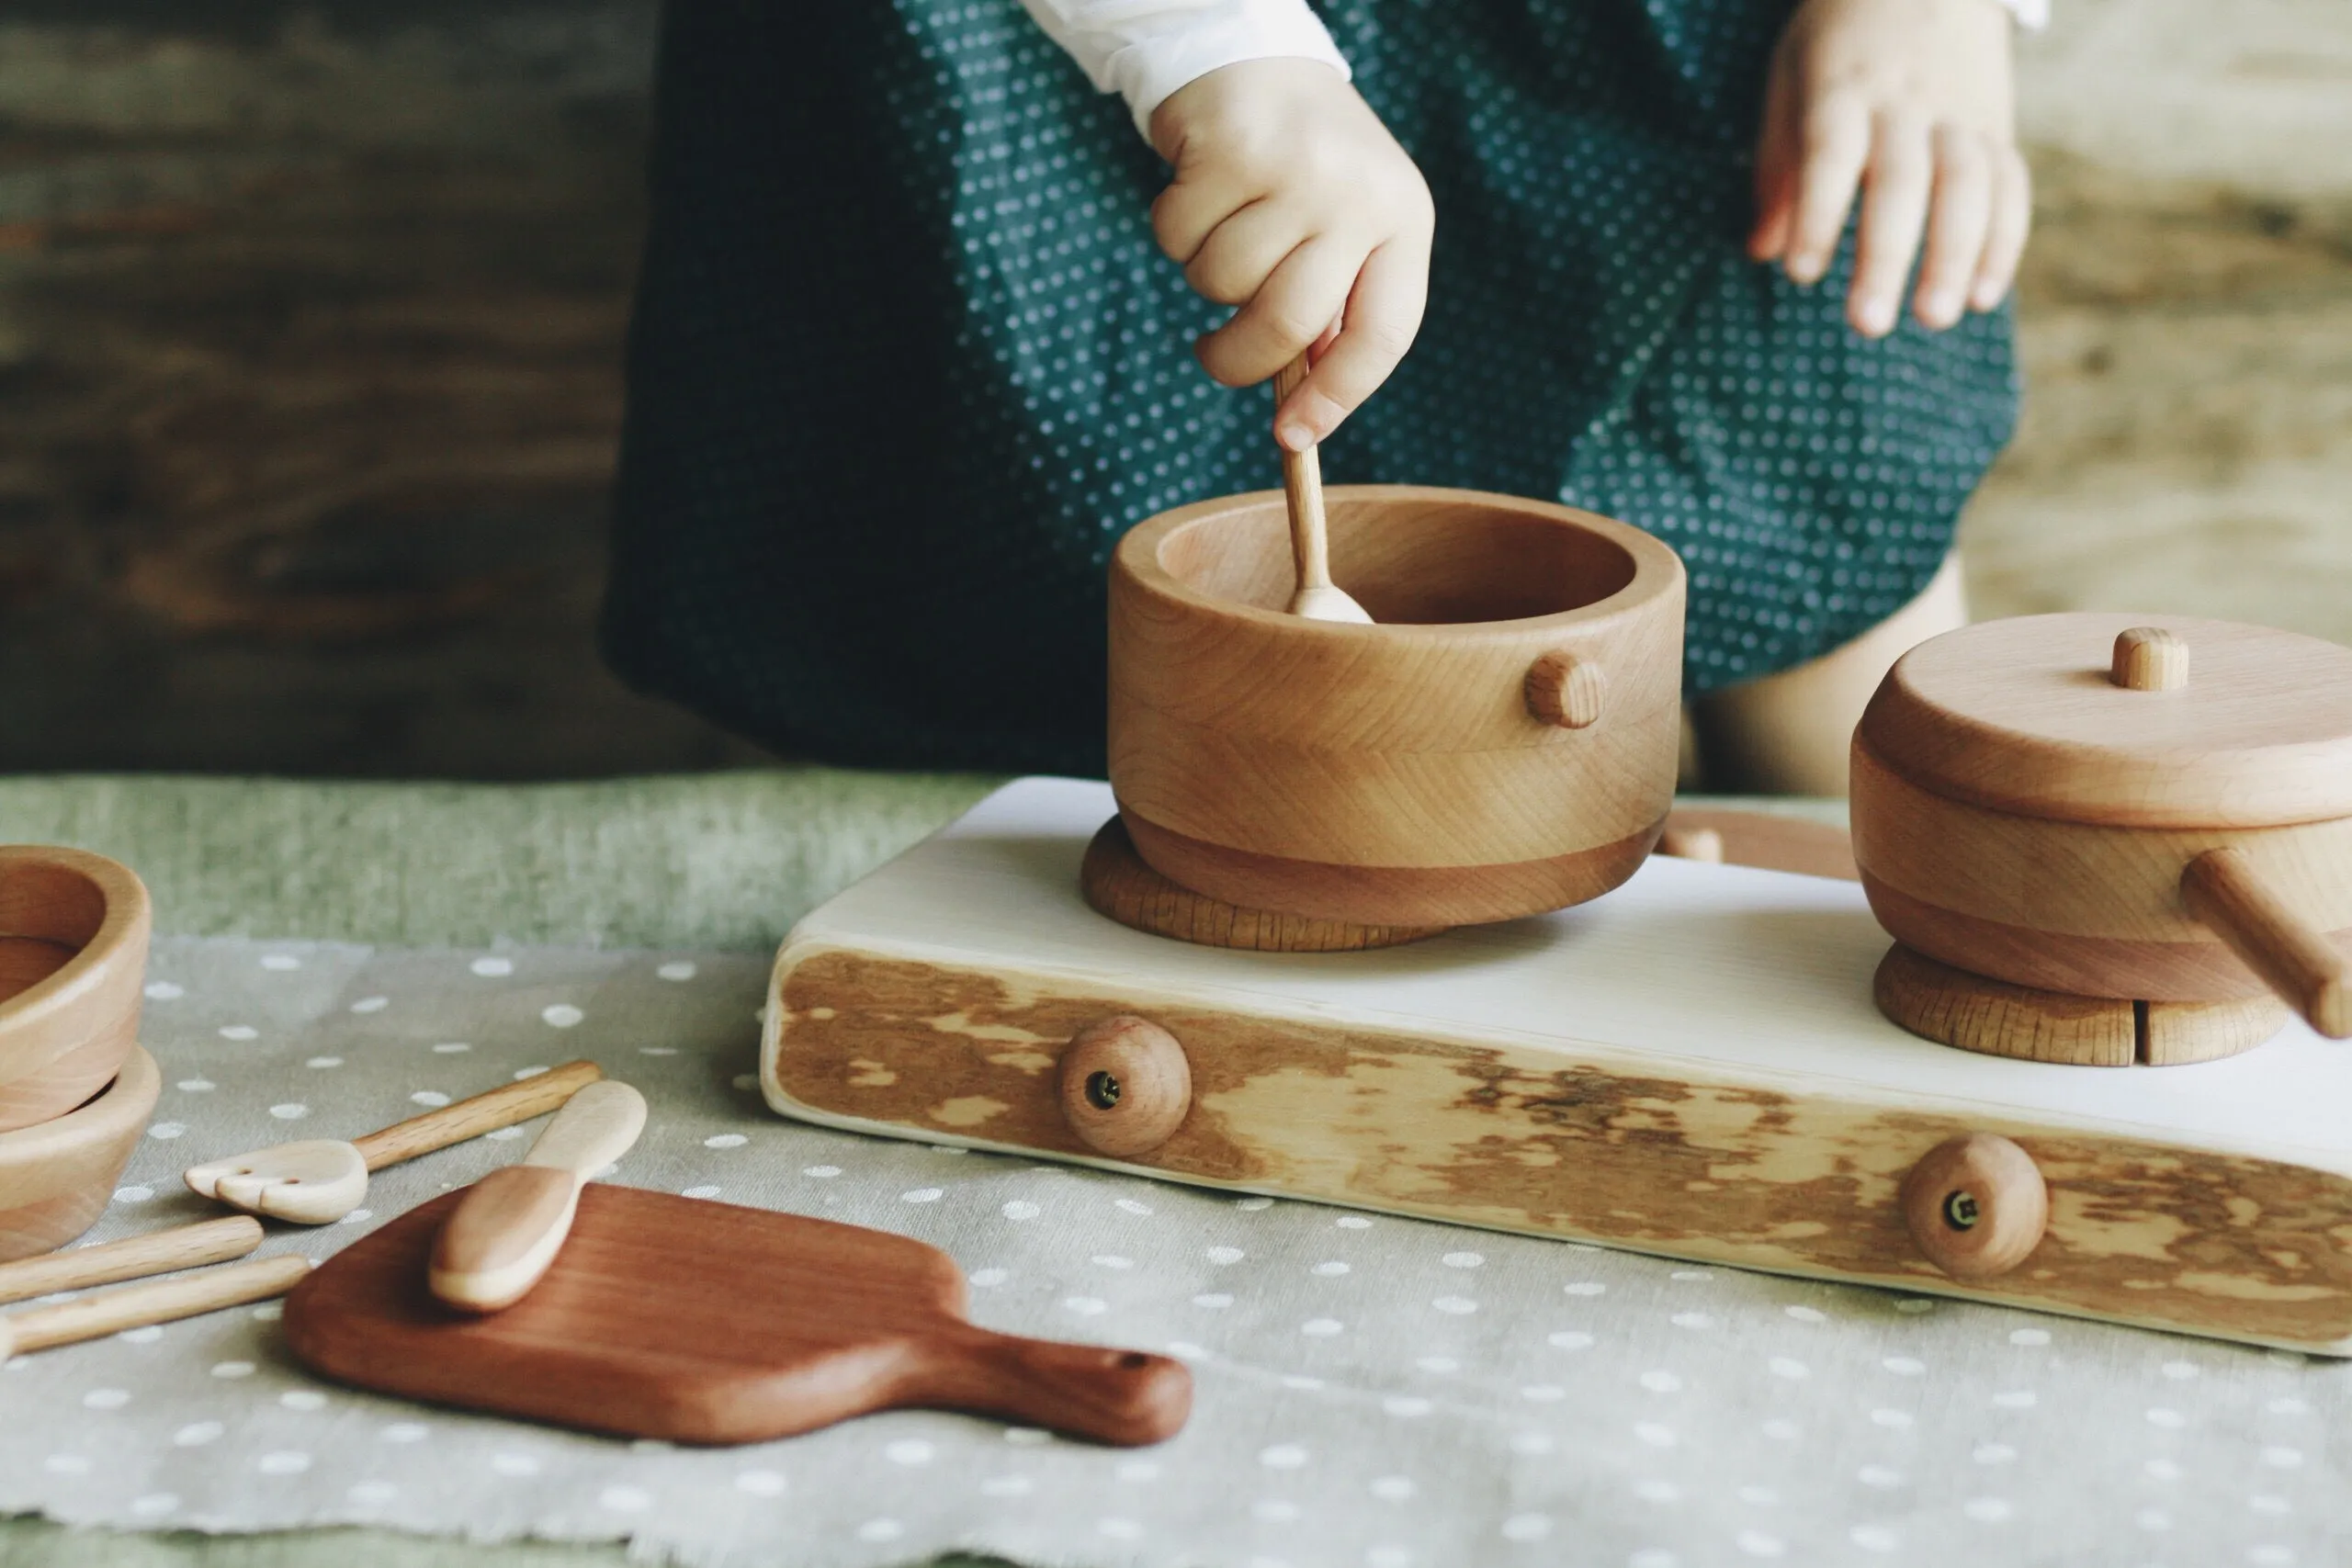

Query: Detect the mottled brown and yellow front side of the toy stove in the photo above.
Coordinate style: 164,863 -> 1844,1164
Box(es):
769,947 -> 2352,1354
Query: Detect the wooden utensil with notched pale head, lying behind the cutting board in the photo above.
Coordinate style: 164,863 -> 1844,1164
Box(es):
188,1063 -> 605,1224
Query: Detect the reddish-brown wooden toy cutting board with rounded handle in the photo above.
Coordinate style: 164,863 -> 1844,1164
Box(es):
285,1185 -> 1193,1443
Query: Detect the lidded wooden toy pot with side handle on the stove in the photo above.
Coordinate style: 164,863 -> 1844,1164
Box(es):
1853,614 -> 2352,1060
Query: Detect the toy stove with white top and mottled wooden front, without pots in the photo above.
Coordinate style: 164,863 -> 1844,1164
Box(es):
762,778 -> 2352,1354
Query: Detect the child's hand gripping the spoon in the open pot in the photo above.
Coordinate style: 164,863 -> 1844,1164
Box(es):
1152,59 -> 1420,451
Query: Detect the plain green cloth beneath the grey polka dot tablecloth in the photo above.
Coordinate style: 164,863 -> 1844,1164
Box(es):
0,769 -> 1837,1568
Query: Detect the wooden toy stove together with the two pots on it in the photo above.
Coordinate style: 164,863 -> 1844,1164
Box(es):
762,482 -> 2352,1354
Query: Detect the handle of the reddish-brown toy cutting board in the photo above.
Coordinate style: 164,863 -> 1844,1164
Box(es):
903,1328 -> 1193,1446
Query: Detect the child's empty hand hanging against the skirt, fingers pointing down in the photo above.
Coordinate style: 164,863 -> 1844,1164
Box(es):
1747,0 -> 2032,336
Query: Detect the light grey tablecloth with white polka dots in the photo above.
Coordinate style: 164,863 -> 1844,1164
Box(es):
0,941 -> 2352,1568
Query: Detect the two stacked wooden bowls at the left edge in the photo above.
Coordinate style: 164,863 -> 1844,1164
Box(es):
0,844 -> 163,1260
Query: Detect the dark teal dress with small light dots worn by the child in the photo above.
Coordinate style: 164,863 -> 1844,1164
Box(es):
605,0 -> 2016,776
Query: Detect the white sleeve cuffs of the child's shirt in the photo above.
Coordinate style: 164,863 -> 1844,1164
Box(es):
1021,0 -> 2049,139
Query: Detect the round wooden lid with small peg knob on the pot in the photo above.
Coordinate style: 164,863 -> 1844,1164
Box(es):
1856,614 -> 2352,828
